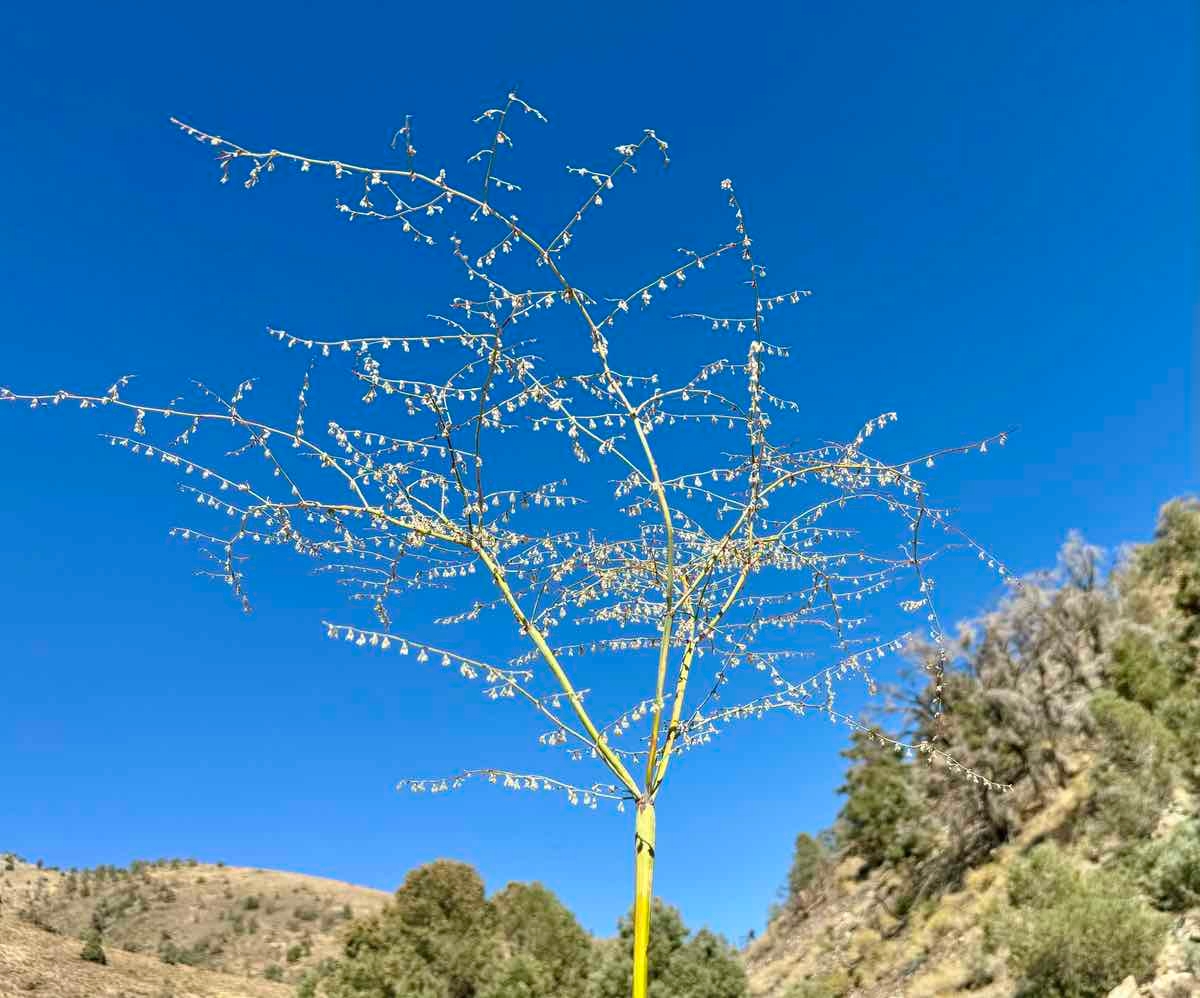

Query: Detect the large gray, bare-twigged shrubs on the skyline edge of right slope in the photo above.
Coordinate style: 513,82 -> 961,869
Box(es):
878,536 -> 1117,897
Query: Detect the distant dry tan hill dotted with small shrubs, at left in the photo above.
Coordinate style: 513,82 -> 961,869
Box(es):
0,856 -> 389,994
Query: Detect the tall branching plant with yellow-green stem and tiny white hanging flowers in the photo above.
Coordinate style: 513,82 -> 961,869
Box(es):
0,94 -> 1007,998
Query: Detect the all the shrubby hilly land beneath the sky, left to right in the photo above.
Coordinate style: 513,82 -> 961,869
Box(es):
0,501 -> 1200,998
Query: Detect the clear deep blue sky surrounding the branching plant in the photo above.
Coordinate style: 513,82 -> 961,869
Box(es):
0,2 -> 1196,936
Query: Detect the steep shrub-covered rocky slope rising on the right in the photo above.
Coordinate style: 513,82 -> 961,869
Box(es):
745,500 -> 1200,998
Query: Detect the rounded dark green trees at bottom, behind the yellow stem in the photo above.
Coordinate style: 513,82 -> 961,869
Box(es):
298,860 -> 746,998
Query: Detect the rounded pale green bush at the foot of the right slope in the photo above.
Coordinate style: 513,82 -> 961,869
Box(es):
994,846 -> 1166,998
